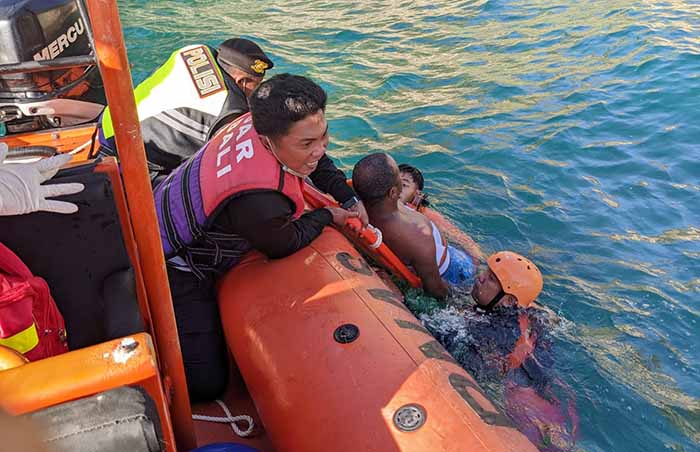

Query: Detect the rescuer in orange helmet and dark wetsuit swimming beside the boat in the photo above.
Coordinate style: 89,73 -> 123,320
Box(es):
422,251 -> 578,452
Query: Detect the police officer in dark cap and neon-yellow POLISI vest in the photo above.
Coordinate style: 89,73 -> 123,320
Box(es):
99,38 -> 274,178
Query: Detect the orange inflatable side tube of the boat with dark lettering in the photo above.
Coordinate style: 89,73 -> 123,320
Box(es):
219,228 -> 537,452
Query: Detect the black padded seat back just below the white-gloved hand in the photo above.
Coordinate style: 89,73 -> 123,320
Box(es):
0,158 -> 147,350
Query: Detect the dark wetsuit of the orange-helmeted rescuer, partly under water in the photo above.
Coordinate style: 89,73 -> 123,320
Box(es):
422,307 -> 578,452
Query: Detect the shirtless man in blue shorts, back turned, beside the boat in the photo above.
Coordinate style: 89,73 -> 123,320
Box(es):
352,153 -> 474,298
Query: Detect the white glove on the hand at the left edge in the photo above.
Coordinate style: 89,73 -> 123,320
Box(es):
0,143 -> 85,216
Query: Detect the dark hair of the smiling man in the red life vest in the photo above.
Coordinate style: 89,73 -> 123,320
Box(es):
250,74 -> 327,137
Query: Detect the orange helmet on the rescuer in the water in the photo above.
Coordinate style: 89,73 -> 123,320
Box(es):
488,251 -> 542,308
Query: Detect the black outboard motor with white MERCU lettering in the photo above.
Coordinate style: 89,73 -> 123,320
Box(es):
0,0 -> 107,136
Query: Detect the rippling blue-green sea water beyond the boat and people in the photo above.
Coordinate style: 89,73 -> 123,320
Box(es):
119,0 -> 700,452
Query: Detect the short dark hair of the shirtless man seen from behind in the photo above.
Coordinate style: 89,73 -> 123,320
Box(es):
352,152 -> 399,205
